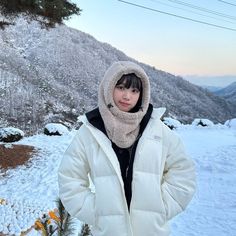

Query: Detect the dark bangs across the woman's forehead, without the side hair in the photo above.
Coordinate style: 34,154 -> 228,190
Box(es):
116,73 -> 142,92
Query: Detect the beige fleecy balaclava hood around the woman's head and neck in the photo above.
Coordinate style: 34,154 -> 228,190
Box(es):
98,61 -> 150,148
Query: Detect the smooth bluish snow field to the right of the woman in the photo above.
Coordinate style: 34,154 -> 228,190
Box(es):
172,125 -> 236,236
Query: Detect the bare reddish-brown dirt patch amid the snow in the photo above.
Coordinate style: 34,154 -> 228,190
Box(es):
0,144 -> 37,169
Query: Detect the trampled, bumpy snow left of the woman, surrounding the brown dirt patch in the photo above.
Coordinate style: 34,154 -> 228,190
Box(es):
0,131 -> 80,235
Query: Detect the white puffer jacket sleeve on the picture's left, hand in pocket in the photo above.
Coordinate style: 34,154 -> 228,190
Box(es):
58,127 -> 95,225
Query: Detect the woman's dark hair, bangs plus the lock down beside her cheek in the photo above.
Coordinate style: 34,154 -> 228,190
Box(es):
116,73 -> 143,113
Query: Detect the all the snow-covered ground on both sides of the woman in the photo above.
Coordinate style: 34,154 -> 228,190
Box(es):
0,125 -> 236,236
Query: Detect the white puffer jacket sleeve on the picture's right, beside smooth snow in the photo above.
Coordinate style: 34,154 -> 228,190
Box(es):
161,128 -> 196,220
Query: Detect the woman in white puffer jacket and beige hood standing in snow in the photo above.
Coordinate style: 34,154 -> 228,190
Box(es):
59,61 -> 195,236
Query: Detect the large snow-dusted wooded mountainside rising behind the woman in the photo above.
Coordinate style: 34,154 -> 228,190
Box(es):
0,18 -> 236,133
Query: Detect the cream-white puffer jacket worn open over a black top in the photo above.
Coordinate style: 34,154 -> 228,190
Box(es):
59,109 -> 195,236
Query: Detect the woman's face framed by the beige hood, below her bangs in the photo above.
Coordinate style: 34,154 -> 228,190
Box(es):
113,84 -> 140,112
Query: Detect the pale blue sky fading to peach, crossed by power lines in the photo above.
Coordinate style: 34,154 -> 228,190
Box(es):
65,0 -> 236,85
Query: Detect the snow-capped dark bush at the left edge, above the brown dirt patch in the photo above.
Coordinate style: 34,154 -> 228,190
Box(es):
0,127 -> 25,143
